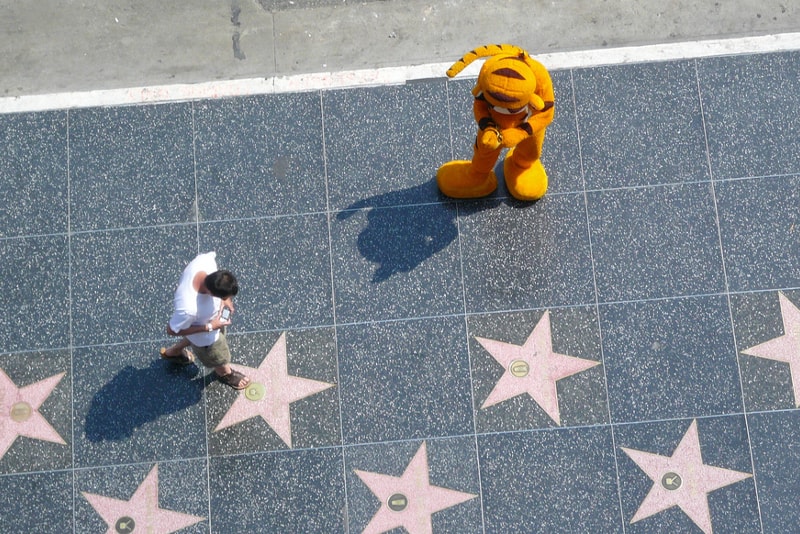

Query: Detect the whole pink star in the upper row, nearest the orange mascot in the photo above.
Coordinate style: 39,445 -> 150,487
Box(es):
475,311 -> 600,425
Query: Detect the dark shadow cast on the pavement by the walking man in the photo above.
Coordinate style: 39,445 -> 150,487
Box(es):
85,360 -> 206,442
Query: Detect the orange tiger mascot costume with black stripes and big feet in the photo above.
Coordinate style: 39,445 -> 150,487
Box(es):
436,44 -> 555,200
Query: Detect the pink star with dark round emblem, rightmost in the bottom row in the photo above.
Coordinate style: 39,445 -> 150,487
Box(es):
621,420 -> 753,534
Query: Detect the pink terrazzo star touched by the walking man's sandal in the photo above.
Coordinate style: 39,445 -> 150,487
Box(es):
214,332 -> 333,447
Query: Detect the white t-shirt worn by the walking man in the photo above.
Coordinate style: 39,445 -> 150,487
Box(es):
169,252 -> 222,347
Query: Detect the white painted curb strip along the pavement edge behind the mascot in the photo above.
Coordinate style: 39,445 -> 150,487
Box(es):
0,32 -> 800,114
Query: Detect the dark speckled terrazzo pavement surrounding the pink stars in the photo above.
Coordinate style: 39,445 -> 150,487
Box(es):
0,48 -> 800,534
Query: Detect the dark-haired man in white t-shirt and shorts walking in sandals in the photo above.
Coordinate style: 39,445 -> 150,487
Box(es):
161,252 -> 250,389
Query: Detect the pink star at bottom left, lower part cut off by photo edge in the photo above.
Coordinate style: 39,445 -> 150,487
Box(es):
82,464 -> 205,534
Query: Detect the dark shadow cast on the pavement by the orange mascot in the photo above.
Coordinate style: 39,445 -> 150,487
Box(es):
336,178 -> 506,284
